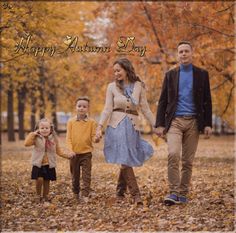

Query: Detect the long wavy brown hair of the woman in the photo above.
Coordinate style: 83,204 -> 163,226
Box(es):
113,58 -> 142,90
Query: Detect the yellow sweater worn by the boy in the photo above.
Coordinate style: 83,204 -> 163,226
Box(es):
66,117 -> 97,154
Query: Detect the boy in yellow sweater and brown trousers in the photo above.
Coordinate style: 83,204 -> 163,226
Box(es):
66,96 -> 99,200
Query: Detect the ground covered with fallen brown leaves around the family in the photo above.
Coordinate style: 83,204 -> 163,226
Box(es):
1,136 -> 234,232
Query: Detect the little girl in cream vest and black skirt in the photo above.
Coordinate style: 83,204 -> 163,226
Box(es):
25,118 -> 70,201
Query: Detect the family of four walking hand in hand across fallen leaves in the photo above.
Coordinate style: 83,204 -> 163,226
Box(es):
25,41 -> 212,205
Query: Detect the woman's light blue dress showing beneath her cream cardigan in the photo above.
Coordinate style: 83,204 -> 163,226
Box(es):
104,85 -> 154,167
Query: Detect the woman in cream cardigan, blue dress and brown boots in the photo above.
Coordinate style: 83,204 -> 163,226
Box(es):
97,58 -> 154,204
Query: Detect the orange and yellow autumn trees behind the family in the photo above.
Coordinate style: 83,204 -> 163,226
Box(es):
0,1 -> 235,141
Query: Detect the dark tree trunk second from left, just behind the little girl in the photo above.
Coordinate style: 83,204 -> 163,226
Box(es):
17,85 -> 26,140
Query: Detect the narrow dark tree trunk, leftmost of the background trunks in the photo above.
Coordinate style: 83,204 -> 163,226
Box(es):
7,78 -> 15,141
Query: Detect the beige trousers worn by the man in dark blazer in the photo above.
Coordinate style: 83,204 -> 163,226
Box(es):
167,117 -> 199,196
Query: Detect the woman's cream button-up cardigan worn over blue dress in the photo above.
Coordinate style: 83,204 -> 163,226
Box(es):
99,81 -> 154,130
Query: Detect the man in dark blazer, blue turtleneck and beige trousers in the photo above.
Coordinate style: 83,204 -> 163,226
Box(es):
154,41 -> 212,205
